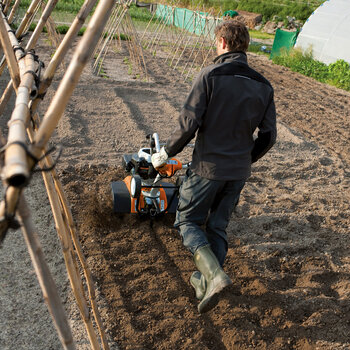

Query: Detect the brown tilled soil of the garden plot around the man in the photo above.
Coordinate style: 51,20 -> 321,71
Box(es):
2,33 -> 350,350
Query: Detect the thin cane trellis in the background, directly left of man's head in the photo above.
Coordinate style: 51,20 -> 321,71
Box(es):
141,2 -> 221,80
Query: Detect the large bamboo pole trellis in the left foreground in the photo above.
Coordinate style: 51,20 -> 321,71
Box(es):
0,0 -> 119,349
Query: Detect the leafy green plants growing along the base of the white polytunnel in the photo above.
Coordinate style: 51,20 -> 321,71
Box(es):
272,49 -> 350,91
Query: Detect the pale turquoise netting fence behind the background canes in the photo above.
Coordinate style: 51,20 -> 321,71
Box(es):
156,4 -> 215,37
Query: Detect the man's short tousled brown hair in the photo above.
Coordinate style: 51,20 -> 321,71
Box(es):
215,20 -> 249,52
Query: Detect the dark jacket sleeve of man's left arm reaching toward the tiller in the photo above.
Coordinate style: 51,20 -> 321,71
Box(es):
165,70 -> 209,157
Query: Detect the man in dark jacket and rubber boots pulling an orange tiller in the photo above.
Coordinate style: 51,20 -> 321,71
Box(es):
152,20 -> 277,313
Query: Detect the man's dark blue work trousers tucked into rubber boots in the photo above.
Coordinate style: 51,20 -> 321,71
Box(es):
174,170 -> 246,266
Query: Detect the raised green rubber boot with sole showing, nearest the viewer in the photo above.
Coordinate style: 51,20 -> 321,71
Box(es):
193,245 -> 232,313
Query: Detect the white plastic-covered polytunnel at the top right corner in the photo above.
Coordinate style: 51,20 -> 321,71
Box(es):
295,0 -> 350,64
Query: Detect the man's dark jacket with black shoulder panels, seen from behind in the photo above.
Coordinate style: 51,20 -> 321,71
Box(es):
165,52 -> 277,180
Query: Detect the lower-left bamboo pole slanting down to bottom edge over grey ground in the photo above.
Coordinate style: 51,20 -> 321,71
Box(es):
18,195 -> 75,350
